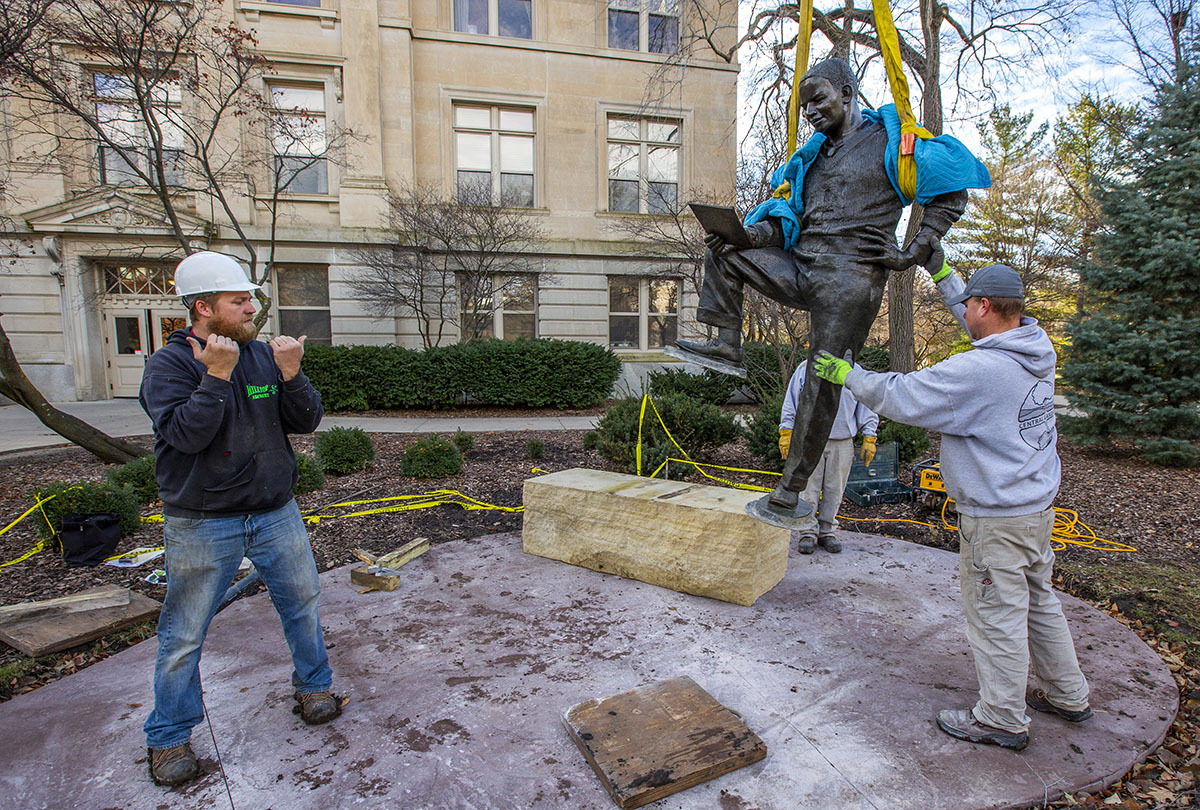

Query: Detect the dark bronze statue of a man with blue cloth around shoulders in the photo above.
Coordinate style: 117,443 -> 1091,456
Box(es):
676,59 -> 991,528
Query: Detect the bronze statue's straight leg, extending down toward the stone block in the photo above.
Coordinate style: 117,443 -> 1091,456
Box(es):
772,264 -> 887,506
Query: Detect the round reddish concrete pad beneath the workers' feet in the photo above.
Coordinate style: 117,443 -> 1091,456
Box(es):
0,534 -> 1178,810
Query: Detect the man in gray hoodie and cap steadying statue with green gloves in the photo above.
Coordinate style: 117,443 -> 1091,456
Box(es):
814,246 -> 1092,750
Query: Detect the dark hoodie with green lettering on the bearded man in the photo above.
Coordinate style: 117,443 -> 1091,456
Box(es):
138,329 -> 324,517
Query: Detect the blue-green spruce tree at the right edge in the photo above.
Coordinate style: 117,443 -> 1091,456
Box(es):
1060,54 -> 1200,466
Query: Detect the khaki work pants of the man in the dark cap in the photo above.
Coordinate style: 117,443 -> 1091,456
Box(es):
959,509 -> 1087,733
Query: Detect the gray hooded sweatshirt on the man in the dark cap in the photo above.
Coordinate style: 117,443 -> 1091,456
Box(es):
846,274 -> 1060,517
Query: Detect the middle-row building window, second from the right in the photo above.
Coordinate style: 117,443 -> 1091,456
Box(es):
454,104 -> 534,208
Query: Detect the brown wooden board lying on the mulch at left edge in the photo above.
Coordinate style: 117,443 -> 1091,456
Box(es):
0,586 -> 162,658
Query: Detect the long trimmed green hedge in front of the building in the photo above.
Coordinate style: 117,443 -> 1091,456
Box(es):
302,338 -> 620,412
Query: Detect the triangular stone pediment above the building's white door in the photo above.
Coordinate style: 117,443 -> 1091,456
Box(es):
23,190 -> 209,238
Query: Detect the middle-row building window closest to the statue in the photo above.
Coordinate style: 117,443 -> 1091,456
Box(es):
608,115 -> 680,214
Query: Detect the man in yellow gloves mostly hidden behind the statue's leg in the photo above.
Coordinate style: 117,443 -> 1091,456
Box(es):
779,362 -> 880,554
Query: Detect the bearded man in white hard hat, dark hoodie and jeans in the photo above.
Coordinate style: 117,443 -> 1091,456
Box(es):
138,251 -> 342,785
